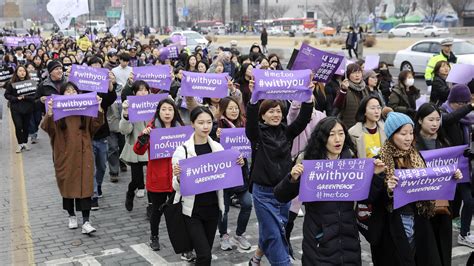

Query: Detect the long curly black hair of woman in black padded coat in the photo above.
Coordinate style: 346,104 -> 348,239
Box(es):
304,116 -> 355,160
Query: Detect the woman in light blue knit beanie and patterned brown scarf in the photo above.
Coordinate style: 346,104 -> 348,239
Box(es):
374,112 -> 462,265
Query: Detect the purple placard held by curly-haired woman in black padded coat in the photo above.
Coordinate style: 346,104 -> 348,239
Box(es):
299,159 -> 374,202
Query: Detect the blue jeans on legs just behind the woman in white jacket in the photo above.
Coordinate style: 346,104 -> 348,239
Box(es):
219,189 -> 252,236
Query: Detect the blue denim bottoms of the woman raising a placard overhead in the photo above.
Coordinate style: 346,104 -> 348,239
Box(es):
252,184 -> 290,265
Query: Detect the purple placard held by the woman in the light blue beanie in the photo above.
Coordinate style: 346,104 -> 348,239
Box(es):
393,165 -> 457,209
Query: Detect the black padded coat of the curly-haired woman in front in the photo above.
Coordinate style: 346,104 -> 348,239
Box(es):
274,151 -> 384,265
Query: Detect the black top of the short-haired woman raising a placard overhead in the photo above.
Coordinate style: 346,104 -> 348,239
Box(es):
245,100 -> 313,187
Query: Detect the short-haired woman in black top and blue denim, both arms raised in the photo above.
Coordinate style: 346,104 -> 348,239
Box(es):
245,80 -> 314,265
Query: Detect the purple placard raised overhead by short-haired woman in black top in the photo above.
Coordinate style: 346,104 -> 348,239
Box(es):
252,69 -> 313,102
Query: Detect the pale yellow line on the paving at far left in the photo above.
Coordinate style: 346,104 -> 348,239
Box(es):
8,109 -> 35,265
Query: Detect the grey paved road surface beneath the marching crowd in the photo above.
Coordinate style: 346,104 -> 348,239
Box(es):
0,91 -> 471,266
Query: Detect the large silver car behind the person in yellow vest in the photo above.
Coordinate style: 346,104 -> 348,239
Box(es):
393,39 -> 474,74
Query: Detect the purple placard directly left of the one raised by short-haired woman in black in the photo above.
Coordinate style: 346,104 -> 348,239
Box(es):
180,71 -> 228,98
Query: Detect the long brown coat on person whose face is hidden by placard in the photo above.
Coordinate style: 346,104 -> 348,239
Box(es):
41,112 -> 104,199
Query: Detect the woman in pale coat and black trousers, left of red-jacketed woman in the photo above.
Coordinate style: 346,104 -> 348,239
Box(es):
119,80 -> 150,211
